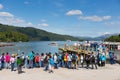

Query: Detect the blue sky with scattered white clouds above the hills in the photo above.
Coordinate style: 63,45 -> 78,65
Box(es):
0,0 -> 120,37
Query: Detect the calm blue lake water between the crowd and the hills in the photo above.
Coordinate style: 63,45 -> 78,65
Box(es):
0,41 -> 74,54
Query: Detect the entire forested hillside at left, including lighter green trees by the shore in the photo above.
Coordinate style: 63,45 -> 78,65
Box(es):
0,24 -> 80,42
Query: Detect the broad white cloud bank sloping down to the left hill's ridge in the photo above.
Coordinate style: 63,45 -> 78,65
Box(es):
0,12 -> 35,27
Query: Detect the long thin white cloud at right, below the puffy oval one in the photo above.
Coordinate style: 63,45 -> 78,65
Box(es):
79,15 -> 111,22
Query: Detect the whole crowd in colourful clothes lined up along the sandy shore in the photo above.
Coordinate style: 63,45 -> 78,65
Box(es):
0,51 -> 115,73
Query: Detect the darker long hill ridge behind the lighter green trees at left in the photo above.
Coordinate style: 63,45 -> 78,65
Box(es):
0,24 -> 82,41
